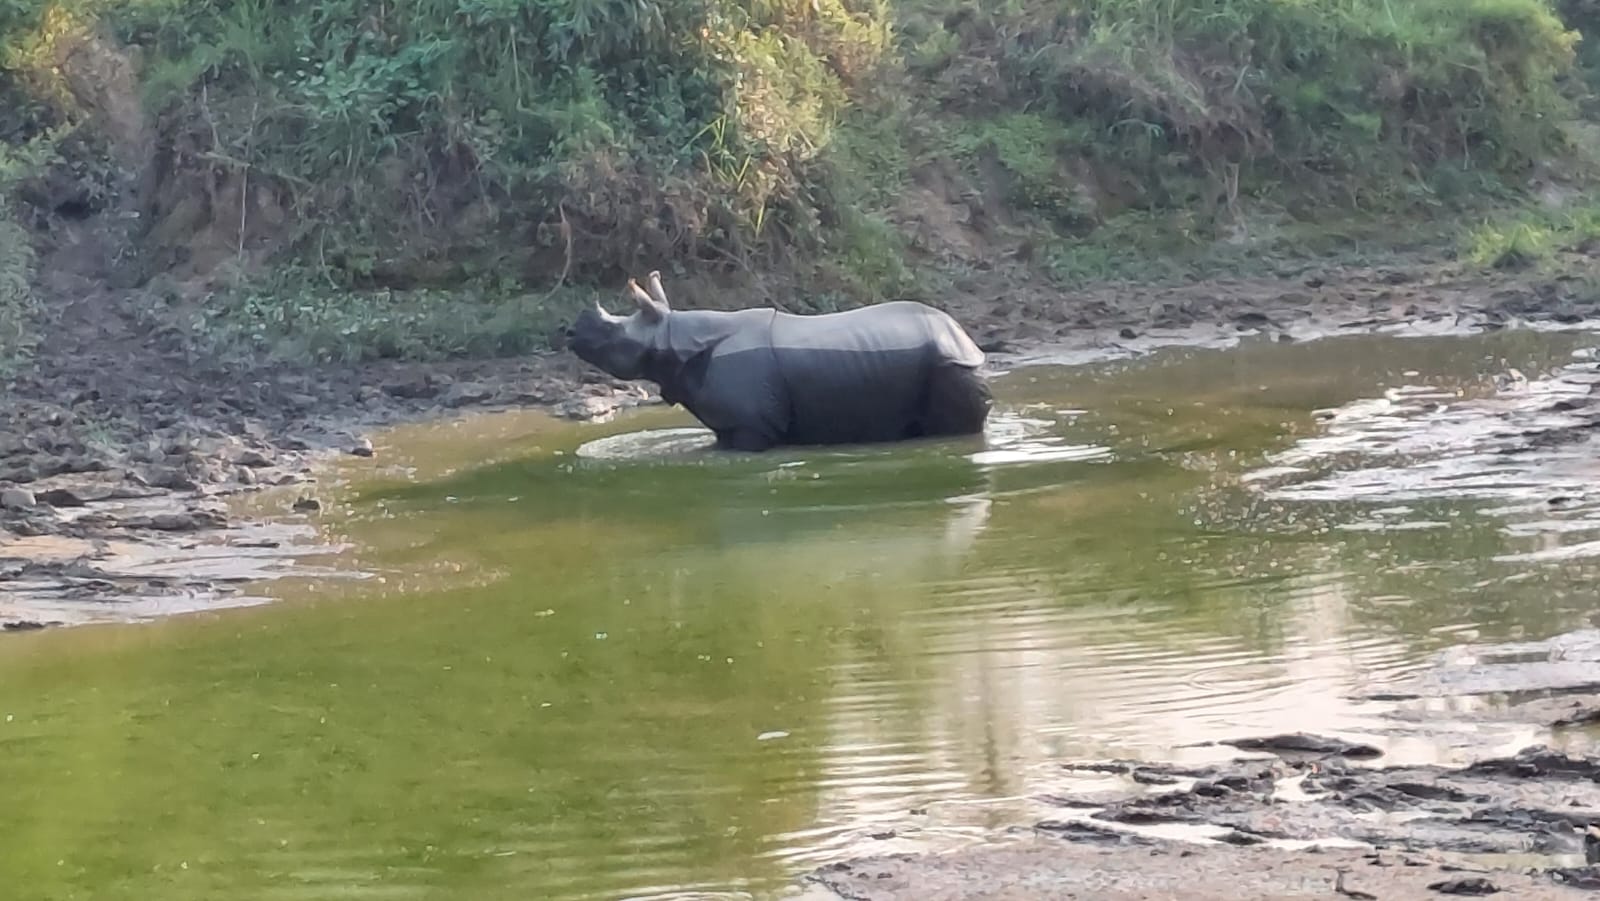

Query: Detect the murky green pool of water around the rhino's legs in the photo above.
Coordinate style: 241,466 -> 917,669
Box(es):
0,333 -> 1600,899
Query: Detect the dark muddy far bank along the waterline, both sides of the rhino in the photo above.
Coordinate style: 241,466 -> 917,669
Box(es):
0,246 -> 1597,629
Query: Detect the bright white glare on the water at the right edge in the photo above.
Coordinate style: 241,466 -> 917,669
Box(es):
1250,347 -> 1600,563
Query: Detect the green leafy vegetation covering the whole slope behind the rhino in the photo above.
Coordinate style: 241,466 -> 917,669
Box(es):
0,0 -> 1600,357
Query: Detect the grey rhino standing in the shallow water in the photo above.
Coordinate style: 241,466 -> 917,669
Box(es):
566,272 -> 992,451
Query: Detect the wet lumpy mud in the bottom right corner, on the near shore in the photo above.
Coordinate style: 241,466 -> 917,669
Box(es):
797,735 -> 1600,901
